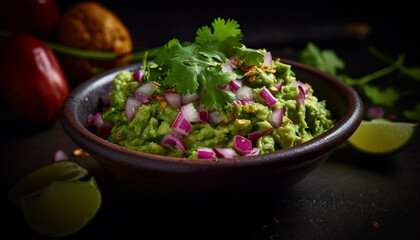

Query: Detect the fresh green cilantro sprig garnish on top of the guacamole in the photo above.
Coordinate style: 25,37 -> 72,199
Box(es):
145,18 -> 264,111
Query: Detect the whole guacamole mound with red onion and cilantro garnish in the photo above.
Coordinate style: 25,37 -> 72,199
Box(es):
89,18 -> 334,159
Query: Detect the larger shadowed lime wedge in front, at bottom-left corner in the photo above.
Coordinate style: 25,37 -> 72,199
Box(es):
21,177 -> 102,237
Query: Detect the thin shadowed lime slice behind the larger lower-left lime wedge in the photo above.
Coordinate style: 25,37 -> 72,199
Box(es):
8,161 -> 88,204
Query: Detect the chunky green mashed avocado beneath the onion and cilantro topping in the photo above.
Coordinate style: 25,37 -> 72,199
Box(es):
96,60 -> 334,158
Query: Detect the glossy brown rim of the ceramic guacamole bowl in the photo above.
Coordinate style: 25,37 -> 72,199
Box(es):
60,59 -> 363,171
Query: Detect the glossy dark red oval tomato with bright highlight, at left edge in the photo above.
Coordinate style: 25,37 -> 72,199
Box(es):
0,34 -> 70,122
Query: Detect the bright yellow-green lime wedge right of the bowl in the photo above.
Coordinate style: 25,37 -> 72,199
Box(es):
348,120 -> 418,154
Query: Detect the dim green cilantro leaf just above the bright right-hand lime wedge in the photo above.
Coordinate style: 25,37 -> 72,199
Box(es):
361,84 -> 400,107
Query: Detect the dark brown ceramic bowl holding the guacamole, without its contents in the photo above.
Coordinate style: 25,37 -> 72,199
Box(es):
60,60 -> 363,201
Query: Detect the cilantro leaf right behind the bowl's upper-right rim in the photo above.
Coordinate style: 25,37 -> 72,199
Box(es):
300,42 -> 345,76
